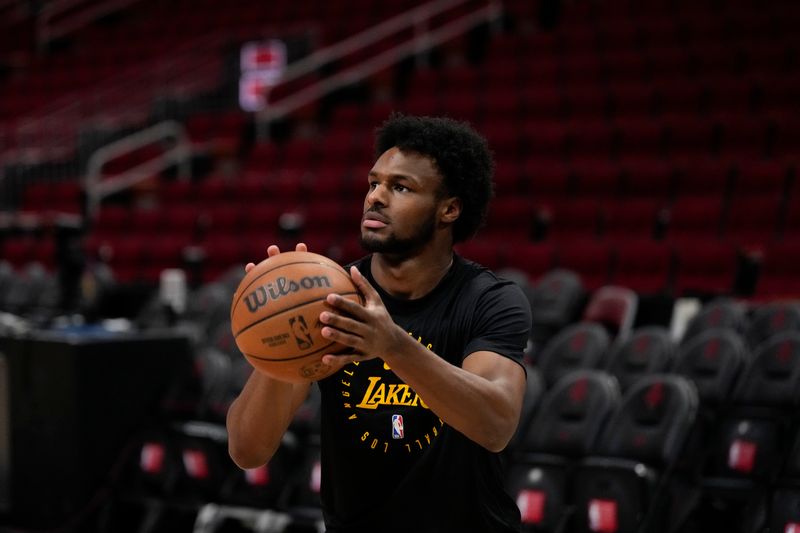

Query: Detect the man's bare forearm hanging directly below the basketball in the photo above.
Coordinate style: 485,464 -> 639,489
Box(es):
226,372 -> 309,468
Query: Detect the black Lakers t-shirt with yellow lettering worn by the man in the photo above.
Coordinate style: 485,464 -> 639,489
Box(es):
319,256 -> 531,533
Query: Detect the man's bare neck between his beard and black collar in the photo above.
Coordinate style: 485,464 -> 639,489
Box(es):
371,247 -> 453,300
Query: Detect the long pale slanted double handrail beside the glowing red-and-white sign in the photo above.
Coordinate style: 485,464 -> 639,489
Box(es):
256,0 -> 502,138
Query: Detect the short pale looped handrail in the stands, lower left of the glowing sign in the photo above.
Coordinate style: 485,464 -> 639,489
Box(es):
85,121 -> 192,217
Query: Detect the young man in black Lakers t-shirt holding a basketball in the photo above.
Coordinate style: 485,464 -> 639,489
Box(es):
228,115 -> 531,533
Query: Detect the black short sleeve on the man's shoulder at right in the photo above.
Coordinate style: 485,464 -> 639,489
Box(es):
462,281 -> 531,364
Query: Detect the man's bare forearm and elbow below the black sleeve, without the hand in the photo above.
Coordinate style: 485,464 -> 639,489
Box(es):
384,335 -> 525,452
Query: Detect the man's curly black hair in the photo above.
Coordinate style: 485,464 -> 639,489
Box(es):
375,113 -> 494,242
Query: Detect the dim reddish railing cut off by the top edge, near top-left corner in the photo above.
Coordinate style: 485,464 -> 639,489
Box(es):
36,0 -> 145,49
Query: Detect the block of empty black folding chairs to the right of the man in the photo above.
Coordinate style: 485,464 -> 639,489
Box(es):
508,300 -> 800,532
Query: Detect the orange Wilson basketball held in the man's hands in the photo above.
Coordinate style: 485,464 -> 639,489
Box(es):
231,252 -> 361,383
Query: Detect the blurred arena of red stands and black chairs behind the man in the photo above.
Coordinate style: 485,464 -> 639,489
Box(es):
0,0 -> 800,533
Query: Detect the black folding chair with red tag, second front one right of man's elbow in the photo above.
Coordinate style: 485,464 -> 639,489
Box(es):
571,374 -> 698,533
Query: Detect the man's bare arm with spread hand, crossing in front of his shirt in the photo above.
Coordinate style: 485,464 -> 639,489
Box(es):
321,269 -> 525,452
